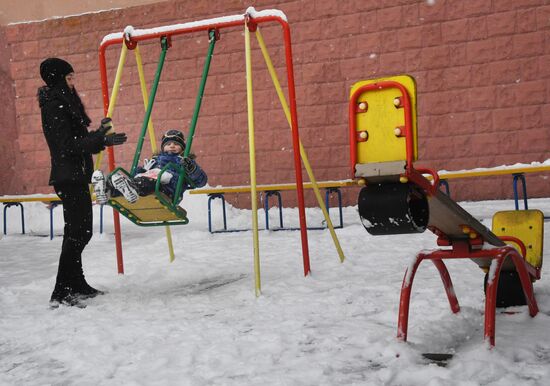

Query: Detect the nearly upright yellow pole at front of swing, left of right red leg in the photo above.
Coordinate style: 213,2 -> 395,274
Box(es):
244,23 -> 262,296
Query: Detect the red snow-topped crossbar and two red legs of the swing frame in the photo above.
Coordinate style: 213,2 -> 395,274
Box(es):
99,12 -> 311,276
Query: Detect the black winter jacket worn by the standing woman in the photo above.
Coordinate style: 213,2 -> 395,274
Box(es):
38,86 -> 105,185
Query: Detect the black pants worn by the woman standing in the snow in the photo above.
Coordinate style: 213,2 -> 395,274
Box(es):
54,184 -> 93,288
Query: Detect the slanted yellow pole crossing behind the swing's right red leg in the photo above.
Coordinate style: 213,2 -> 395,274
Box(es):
256,27 -> 346,262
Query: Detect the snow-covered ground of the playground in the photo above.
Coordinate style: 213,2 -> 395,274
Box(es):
0,196 -> 550,386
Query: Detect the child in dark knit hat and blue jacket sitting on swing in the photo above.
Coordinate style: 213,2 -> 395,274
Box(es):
92,130 -> 208,204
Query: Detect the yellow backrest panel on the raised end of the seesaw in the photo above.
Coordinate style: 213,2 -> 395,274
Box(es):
350,75 -> 418,164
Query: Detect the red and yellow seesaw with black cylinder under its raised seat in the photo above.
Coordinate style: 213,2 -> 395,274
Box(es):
349,75 -> 543,346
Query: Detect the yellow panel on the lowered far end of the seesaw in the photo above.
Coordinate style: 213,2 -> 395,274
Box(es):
493,209 -> 544,268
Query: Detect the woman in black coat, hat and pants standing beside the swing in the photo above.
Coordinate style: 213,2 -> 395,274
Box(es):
38,58 -> 126,307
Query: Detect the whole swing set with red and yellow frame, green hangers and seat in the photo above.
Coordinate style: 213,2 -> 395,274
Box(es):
95,7 -> 345,296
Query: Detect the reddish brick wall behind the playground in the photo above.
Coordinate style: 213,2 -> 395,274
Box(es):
0,0 -> 550,206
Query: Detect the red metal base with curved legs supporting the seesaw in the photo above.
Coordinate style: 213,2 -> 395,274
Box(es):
397,241 -> 539,347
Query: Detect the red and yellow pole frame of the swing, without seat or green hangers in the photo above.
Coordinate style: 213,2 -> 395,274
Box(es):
98,7 -> 344,296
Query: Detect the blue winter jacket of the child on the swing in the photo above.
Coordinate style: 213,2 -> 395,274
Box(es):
137,152 -> 208,200
